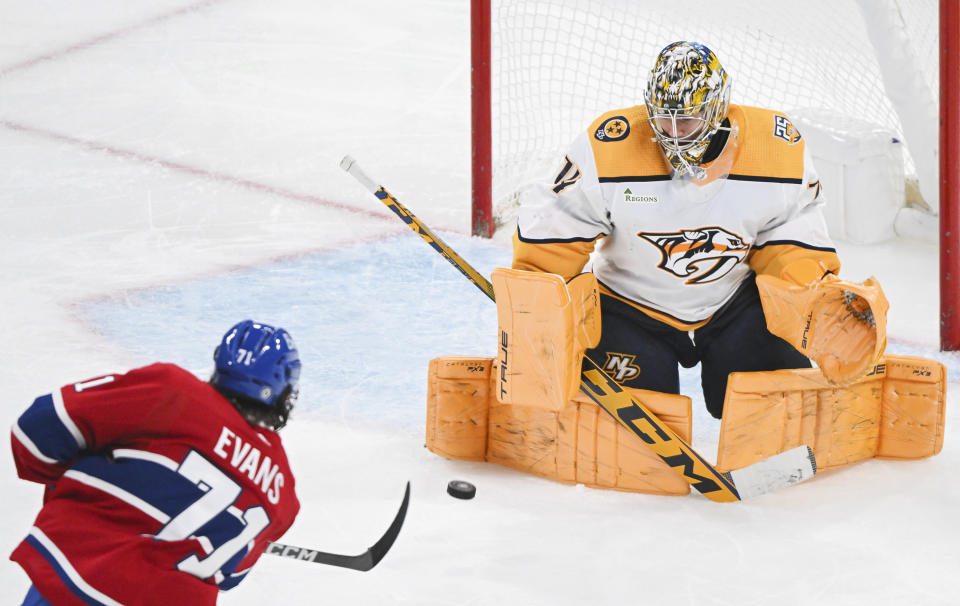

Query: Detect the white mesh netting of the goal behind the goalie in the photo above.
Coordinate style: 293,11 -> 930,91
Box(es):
491,0 -> 938,226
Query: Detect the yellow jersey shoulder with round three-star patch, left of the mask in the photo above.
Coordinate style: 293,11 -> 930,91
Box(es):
587,105 -> 670,181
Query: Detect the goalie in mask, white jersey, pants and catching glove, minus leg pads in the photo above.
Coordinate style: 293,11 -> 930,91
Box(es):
506,42 -> 886,418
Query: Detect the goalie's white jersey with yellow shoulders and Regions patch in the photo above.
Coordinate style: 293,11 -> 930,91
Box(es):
513,105 -> 840,330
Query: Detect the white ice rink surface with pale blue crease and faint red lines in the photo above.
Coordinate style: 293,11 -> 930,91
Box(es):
0,0 -> 960,605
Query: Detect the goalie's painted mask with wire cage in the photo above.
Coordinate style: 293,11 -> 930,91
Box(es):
644,42 -> 730,181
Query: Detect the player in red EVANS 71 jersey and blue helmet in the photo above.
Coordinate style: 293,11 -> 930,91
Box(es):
11,320 -> 300,605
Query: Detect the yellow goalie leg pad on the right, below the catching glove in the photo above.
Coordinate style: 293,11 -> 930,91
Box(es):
717,356 -> 946,471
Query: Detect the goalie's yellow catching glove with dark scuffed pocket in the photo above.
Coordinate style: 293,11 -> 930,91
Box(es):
757,260 -> 890,385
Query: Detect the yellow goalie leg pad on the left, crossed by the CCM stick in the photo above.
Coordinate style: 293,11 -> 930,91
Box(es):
427,357 -> 693,496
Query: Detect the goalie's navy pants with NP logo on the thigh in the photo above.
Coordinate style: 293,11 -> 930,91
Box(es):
588,278 -> 811,419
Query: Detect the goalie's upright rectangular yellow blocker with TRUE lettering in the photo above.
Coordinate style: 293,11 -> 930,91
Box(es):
491,268 -> 600,410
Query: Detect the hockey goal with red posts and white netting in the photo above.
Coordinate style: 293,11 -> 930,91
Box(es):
471,0 -> 960,350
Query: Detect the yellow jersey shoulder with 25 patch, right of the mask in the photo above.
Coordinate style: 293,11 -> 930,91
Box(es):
727,104 -> 806,181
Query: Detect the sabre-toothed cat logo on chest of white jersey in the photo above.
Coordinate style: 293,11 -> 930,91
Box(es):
637,227 -> 750,284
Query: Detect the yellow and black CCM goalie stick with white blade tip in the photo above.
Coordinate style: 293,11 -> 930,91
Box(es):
340,156 -> 817,503
